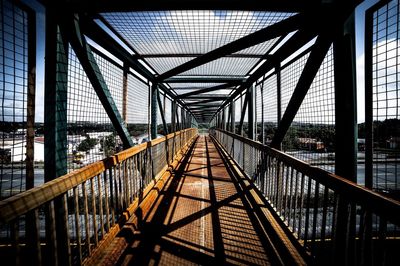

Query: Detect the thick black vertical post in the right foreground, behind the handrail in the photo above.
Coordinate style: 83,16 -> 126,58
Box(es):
333,10 -> 357,265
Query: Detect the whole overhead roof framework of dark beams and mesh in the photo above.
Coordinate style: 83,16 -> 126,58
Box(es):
47,0 -> 360,120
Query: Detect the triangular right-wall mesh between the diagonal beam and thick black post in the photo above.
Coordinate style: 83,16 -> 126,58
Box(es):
282,47 -> 335,172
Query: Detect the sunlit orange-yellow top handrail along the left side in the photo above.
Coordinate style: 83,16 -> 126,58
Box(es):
0,129 -> 195,223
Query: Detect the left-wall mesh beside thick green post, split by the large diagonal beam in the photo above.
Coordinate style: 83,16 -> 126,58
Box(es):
67,48 -> 123,171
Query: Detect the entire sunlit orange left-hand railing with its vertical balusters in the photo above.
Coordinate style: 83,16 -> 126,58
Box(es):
0,129 -> 197,265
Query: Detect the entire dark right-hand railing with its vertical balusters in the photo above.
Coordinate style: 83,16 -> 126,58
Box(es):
211,130 -> 400,265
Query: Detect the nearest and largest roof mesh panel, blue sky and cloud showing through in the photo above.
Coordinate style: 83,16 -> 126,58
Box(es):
102,10 -> 292,54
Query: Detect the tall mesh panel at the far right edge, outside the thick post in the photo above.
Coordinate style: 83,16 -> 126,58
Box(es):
367,0 -> 400,193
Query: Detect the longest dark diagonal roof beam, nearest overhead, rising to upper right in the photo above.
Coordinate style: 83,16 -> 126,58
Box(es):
158,14 -> 304,81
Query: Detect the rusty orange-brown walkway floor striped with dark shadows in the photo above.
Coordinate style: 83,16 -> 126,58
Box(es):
103,136 -> 277,265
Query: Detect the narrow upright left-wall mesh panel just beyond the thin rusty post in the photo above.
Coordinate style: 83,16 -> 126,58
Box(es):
126,74 -> 150,144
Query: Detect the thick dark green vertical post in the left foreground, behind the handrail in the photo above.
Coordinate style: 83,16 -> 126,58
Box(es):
44,9 -> 71,264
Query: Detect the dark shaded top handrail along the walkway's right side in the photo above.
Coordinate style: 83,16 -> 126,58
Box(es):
216,129 -> 400,225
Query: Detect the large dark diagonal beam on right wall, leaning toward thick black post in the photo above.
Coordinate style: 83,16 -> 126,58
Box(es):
271,35 -> 332,148
